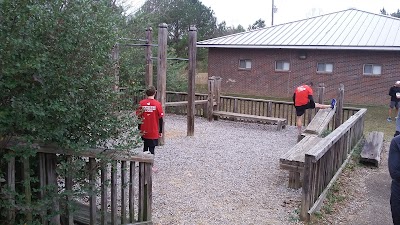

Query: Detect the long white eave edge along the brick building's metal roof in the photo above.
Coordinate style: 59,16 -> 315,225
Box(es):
197,44 -> 400,51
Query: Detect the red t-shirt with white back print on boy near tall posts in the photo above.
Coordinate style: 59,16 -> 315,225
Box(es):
136,98 -> 164,139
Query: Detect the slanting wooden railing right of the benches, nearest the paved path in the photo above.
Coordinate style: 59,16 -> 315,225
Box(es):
300,109 -> 367,220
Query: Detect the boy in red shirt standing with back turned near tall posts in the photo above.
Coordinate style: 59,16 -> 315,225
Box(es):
136,86 -> 164,170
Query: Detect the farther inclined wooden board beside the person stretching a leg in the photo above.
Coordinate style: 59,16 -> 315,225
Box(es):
303,107 -> 336,135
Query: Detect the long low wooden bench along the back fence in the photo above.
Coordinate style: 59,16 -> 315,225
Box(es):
213,111 -> 286,131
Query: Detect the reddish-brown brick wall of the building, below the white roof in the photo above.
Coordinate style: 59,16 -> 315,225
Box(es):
208,48 -> 400,105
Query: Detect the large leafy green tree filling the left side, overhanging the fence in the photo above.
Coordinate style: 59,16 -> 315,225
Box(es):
0,0 -> 140,221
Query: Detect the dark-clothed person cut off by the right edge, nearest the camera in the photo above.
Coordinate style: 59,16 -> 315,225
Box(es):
388,134 -> 400,225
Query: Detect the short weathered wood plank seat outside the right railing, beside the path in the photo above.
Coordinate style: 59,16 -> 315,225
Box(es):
360,131 -> 383,167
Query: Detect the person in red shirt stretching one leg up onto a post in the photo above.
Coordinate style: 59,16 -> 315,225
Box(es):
293,82 -> 336,136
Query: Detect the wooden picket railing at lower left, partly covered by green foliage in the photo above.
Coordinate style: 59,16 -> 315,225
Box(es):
4,142 -> 154,225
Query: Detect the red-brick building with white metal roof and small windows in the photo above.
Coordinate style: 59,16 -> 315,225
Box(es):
197,9 -> 400,105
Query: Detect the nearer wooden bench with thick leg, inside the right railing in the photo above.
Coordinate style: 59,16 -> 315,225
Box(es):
279,135 -> 322,189
